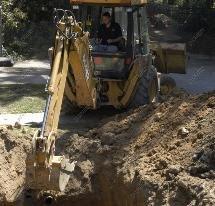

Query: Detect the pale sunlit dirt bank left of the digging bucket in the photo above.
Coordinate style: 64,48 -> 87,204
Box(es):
0,127 -> 30,205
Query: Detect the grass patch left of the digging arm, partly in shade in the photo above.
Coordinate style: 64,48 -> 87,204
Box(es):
0,84 -> 47,114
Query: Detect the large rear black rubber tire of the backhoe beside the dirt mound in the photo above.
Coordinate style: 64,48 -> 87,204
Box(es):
130,66 -> 158,108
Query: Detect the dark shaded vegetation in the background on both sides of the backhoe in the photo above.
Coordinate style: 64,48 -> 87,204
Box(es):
2,0 -> 215,58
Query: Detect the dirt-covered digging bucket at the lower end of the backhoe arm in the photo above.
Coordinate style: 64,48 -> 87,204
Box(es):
26,132 -> 76,191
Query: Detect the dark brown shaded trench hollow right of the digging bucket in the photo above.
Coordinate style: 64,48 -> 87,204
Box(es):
53,168 -> 160,206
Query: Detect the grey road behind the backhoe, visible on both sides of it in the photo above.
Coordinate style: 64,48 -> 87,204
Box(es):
0,55 -> 215,94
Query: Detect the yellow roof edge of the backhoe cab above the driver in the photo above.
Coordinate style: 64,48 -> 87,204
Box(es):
70,0 -> 148,6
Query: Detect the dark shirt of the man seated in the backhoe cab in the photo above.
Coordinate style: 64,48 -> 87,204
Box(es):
98,22 -> 122,47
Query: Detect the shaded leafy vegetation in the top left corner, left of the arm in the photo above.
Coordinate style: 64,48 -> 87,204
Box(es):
2,0 -> 69,58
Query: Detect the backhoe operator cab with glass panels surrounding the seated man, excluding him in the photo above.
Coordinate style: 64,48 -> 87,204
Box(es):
72,5 -> 148,80
